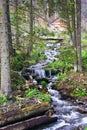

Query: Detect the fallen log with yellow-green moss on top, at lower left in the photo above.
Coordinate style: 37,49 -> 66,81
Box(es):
0,102 -> 52,127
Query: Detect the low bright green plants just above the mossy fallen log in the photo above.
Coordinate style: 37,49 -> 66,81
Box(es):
25,88 -> 51,102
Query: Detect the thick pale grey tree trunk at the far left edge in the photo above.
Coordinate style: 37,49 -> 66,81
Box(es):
0,0 -> 11,96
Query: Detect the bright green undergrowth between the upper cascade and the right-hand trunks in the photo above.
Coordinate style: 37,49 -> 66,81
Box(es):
48,48 -> 74,72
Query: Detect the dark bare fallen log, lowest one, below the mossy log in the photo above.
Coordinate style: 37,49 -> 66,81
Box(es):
0,115 -> 57,130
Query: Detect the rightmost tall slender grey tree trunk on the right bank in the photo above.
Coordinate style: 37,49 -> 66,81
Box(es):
76,0 -> 82,71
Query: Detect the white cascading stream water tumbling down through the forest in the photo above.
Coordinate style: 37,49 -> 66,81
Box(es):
24,43 -> 87,130
